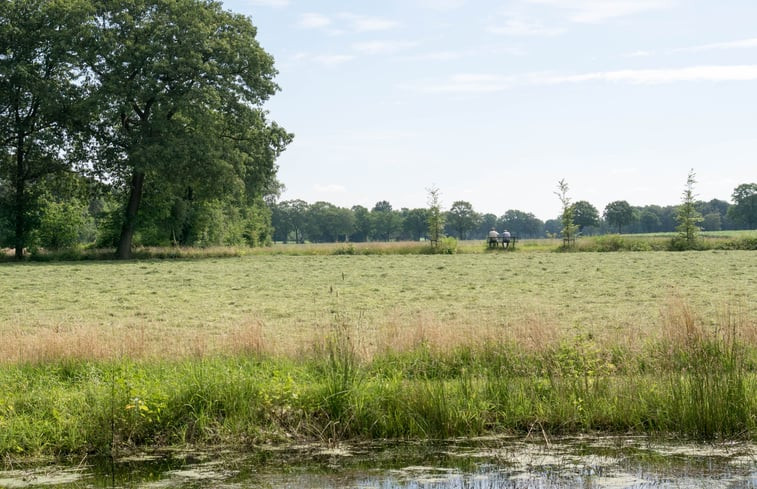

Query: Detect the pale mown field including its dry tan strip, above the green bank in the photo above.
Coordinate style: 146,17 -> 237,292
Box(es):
0,251 -> 757,363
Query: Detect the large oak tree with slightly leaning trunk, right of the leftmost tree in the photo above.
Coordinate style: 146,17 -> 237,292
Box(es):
88,0 -> 291,258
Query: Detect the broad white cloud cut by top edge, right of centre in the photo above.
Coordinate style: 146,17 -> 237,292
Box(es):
526,0 -> 676,23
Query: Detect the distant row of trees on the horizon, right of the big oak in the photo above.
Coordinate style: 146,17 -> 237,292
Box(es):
270,183 -> 757,243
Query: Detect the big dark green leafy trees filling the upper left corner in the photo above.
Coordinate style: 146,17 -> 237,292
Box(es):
0,0 -> 292,258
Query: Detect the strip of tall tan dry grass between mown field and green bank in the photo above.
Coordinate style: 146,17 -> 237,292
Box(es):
0,297 -> 757,365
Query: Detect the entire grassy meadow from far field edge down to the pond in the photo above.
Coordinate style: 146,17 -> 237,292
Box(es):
0,250 -> 757,455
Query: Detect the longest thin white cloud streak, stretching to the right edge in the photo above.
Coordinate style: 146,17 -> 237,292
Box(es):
410,65 -> 757,94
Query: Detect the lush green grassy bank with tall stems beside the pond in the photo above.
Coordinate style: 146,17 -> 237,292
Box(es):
0,306 -> 757,455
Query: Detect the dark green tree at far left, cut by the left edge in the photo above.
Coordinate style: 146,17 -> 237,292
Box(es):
0,0 -> 91,258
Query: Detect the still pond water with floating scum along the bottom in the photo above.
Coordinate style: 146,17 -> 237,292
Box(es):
0,437 -> 757,489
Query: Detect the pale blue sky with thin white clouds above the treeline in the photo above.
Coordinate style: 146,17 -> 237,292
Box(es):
223,0 -> 757,220
